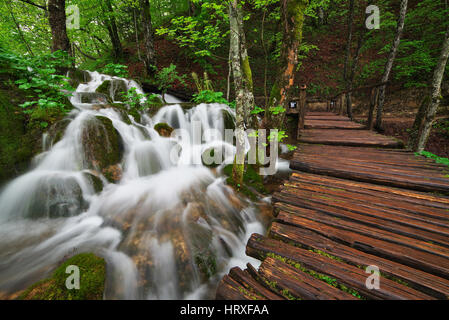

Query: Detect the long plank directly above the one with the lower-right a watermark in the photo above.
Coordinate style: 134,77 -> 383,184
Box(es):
270,223 -> 449,299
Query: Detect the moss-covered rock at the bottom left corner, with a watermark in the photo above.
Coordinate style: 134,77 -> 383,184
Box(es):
18,253 -> 106,300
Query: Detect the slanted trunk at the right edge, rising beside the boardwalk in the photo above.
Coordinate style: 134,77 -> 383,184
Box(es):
413,28 -> 449,152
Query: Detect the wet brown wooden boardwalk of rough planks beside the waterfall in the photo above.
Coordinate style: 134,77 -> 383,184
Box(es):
217,113 -> 449,300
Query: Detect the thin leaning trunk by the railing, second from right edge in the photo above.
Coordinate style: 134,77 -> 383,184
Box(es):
376,0 -> 408,131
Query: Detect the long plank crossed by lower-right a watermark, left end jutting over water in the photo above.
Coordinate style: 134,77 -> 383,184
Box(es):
247,234 -> 433,300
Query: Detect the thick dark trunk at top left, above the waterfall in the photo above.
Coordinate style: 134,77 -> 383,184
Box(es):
48,0 -> 72,55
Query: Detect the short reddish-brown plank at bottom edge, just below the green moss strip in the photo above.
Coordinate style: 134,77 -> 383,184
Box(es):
259,257 -> 357,300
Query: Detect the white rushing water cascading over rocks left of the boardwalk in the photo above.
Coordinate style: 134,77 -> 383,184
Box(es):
0,72 -> 264,299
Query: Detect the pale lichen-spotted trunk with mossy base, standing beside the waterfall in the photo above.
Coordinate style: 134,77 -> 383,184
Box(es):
229,0 -> 245,186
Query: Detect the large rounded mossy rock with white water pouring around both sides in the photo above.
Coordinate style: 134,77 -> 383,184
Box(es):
82,116 -> 124,182
